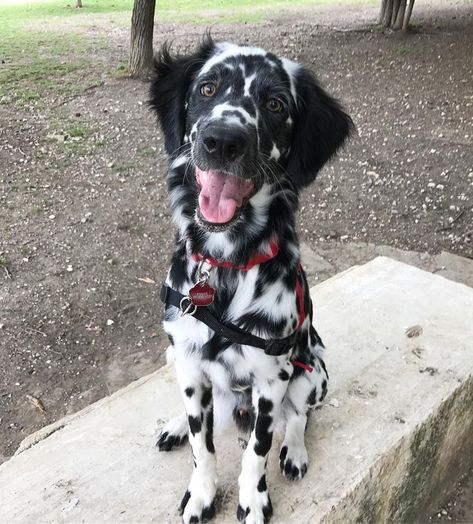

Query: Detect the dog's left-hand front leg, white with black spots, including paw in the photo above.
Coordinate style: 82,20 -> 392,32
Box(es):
176,358 -> 217,524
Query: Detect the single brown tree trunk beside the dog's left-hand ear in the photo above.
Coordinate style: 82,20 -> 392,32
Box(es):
128,0 -> 156,78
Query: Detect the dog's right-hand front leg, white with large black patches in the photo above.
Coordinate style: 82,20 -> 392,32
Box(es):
237,365 -> 291,524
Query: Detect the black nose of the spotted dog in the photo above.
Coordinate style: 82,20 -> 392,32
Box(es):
202,126 -> 248,160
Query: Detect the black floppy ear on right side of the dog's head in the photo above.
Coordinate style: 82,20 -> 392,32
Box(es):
287,68 -> 354,189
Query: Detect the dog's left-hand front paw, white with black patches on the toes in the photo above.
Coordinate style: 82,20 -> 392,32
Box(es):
179,470 -> 217,524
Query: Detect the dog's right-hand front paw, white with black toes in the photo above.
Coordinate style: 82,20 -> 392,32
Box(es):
237,475 -> 273,524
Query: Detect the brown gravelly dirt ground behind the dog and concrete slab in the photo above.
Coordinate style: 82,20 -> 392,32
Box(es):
0,1 -> 473,522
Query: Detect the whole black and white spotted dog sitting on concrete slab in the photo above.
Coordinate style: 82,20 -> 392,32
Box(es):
151,39 -> 352,524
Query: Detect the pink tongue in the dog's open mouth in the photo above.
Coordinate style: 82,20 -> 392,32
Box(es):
195,168 -> 254,224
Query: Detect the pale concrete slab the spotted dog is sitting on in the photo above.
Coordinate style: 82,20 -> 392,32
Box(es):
0,257 -> 473,524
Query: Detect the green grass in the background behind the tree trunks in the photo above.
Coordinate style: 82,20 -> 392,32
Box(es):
0,0 -> 372,107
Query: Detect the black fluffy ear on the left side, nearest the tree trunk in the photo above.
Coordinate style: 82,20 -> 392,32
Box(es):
149,37 -> 215,156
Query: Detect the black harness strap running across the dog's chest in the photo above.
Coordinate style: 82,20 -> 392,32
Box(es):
160,284 -> 297,357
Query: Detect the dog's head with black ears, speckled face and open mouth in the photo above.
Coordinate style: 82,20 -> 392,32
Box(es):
151,39 -> 352,232
